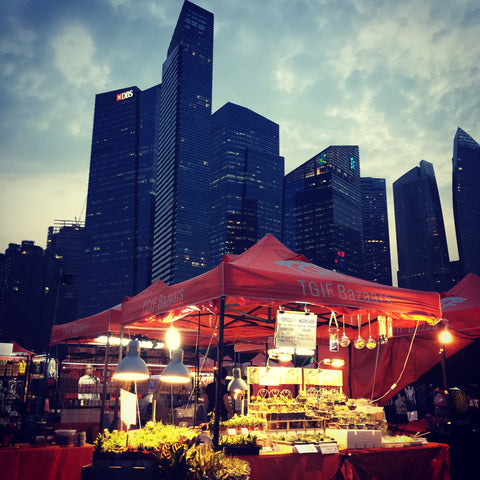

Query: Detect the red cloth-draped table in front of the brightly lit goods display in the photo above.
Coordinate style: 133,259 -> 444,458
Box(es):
240,443 -> 450,480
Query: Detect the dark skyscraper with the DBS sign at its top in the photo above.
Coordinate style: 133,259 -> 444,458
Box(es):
77,85 -> 161,317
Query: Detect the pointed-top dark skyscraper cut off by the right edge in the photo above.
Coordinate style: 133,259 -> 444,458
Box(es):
452,128 -> 480,275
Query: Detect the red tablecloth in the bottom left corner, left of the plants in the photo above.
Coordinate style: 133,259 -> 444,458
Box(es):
0,444 -> 93,480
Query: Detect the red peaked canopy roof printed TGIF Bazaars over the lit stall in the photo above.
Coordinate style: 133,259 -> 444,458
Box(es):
121,234 -> 441,341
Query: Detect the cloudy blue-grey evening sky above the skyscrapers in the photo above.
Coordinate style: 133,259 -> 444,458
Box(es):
0,0 -> 480,282
